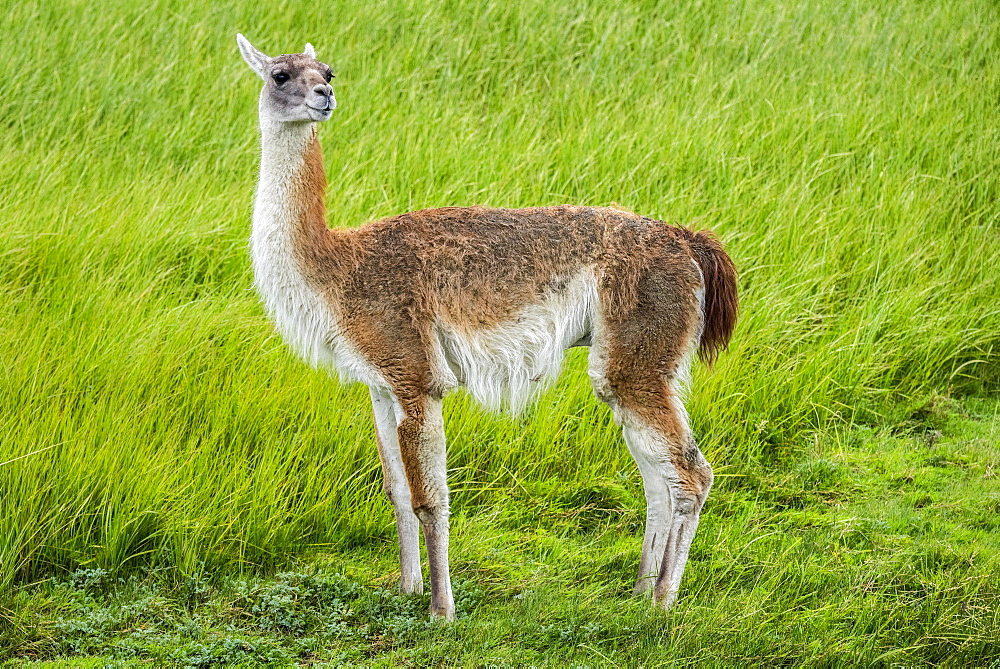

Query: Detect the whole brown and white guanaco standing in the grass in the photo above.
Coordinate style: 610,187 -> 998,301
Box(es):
240,36 -> 738,618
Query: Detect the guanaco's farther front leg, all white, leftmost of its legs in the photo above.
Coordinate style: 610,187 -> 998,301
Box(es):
371,388 -> 424,594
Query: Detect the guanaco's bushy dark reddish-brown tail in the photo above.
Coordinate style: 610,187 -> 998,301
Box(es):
688,230 -> 740,366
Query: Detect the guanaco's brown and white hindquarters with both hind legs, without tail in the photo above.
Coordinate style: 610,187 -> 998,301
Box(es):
590,239 -> 712,608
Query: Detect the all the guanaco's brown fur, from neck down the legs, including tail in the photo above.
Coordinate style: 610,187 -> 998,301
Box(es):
270,115 -> 738,616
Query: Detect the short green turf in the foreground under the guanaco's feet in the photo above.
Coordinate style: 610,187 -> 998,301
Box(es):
7,401 -> 1000,666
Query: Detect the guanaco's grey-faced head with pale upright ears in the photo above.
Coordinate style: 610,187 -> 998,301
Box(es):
236,34 -> 337,123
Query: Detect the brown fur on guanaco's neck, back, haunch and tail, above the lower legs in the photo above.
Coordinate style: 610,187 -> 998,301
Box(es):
296,138 -> 737,412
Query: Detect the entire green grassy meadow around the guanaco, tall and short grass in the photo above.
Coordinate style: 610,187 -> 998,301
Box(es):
0,0 -> 1000,666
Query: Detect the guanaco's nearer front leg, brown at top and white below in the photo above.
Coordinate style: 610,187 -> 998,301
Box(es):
398,395 -> 455,620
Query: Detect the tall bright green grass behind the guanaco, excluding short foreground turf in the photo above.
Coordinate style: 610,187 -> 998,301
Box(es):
0,0 -> 1000,587
